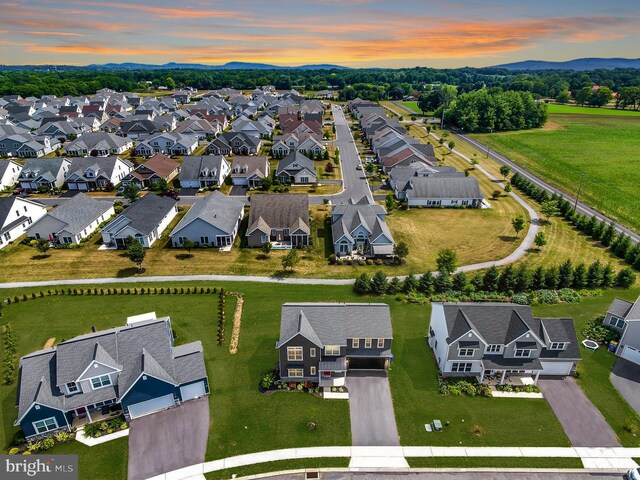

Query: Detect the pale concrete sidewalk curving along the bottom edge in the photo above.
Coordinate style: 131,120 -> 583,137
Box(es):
146,447 -> 640,480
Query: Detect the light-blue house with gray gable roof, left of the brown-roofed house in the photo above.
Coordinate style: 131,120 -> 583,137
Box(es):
169,191 -> 244,248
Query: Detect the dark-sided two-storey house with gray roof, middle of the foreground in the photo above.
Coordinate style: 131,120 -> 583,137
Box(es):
276,303 -> 393,387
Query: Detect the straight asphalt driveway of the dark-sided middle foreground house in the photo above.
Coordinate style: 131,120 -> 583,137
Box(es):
347,371 -> 400,446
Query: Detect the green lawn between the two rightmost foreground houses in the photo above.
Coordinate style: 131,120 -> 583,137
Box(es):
533,287 -> 640,447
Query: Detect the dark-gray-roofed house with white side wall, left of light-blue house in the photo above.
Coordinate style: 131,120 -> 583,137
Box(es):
101,193 -> 178,249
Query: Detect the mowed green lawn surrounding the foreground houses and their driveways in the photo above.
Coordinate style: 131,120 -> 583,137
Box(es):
0,283 -> 640,478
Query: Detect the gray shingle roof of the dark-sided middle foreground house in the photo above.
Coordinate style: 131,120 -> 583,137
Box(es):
277,303 -> 393,347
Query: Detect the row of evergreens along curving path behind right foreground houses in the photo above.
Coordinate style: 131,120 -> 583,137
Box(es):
353,260 -> 636,300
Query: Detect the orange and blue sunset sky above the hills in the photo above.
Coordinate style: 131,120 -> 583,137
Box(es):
0,0 -> 640,67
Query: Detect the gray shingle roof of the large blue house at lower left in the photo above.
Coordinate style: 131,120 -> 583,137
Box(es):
18,317 -> 207,417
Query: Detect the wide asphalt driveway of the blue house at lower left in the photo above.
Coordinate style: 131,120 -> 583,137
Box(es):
129,397 -> 209,480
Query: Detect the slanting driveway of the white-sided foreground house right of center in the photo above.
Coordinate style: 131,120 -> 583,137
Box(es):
538,377 -> 620,447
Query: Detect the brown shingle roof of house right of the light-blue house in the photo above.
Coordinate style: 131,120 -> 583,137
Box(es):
247,193 -> 310,234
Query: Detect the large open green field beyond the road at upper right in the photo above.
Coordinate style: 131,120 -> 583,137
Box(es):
474,113 -> 640,230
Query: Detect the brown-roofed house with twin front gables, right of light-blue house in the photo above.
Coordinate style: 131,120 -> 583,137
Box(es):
247,193 -> 311,249
